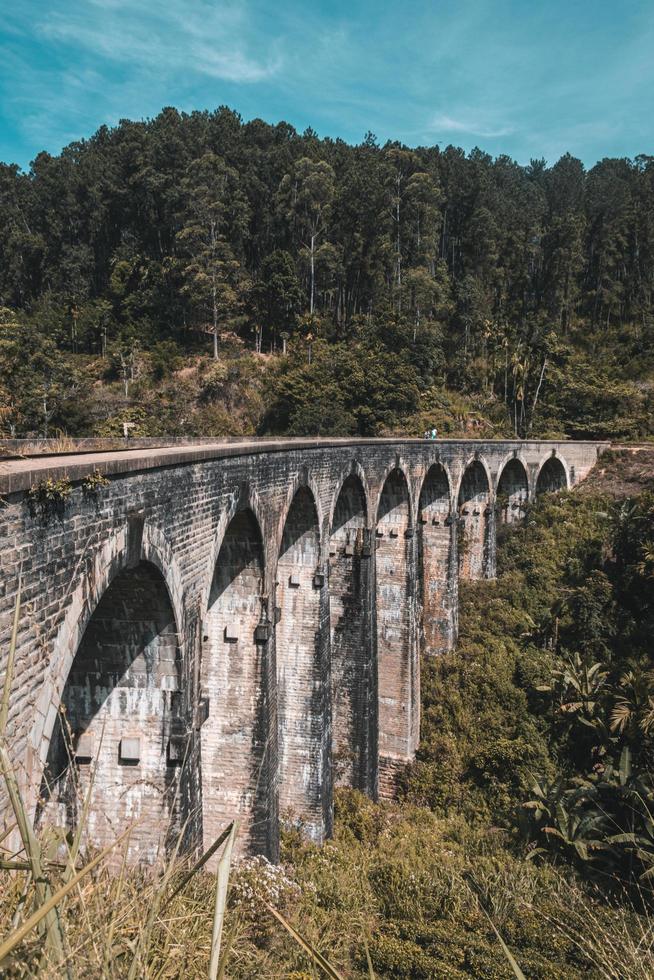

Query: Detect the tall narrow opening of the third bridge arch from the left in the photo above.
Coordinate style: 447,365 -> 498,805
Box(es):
276,487 -> 330,839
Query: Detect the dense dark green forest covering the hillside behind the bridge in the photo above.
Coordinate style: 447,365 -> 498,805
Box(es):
0,107 -> 654,438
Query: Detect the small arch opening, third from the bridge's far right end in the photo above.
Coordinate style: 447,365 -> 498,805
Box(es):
458,459 -> 490,579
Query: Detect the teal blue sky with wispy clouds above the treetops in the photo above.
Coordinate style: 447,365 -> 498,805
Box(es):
0,0 -> 654,168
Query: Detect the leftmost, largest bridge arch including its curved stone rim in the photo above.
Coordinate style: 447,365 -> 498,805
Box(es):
31,522 -> 187,863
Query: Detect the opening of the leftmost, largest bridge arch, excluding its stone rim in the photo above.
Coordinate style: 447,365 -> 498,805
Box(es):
38,561 -> 185,863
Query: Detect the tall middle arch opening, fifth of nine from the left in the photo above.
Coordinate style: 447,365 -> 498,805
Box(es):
375,469 -> 419,796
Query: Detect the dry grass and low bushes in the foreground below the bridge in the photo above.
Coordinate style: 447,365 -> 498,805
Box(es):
0,792 -> 654,980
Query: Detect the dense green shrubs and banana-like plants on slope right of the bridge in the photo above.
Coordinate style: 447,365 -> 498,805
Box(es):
404,493 -> 654,891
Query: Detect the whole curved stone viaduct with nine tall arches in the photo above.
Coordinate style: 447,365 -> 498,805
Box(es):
0,439 -> 606,862
